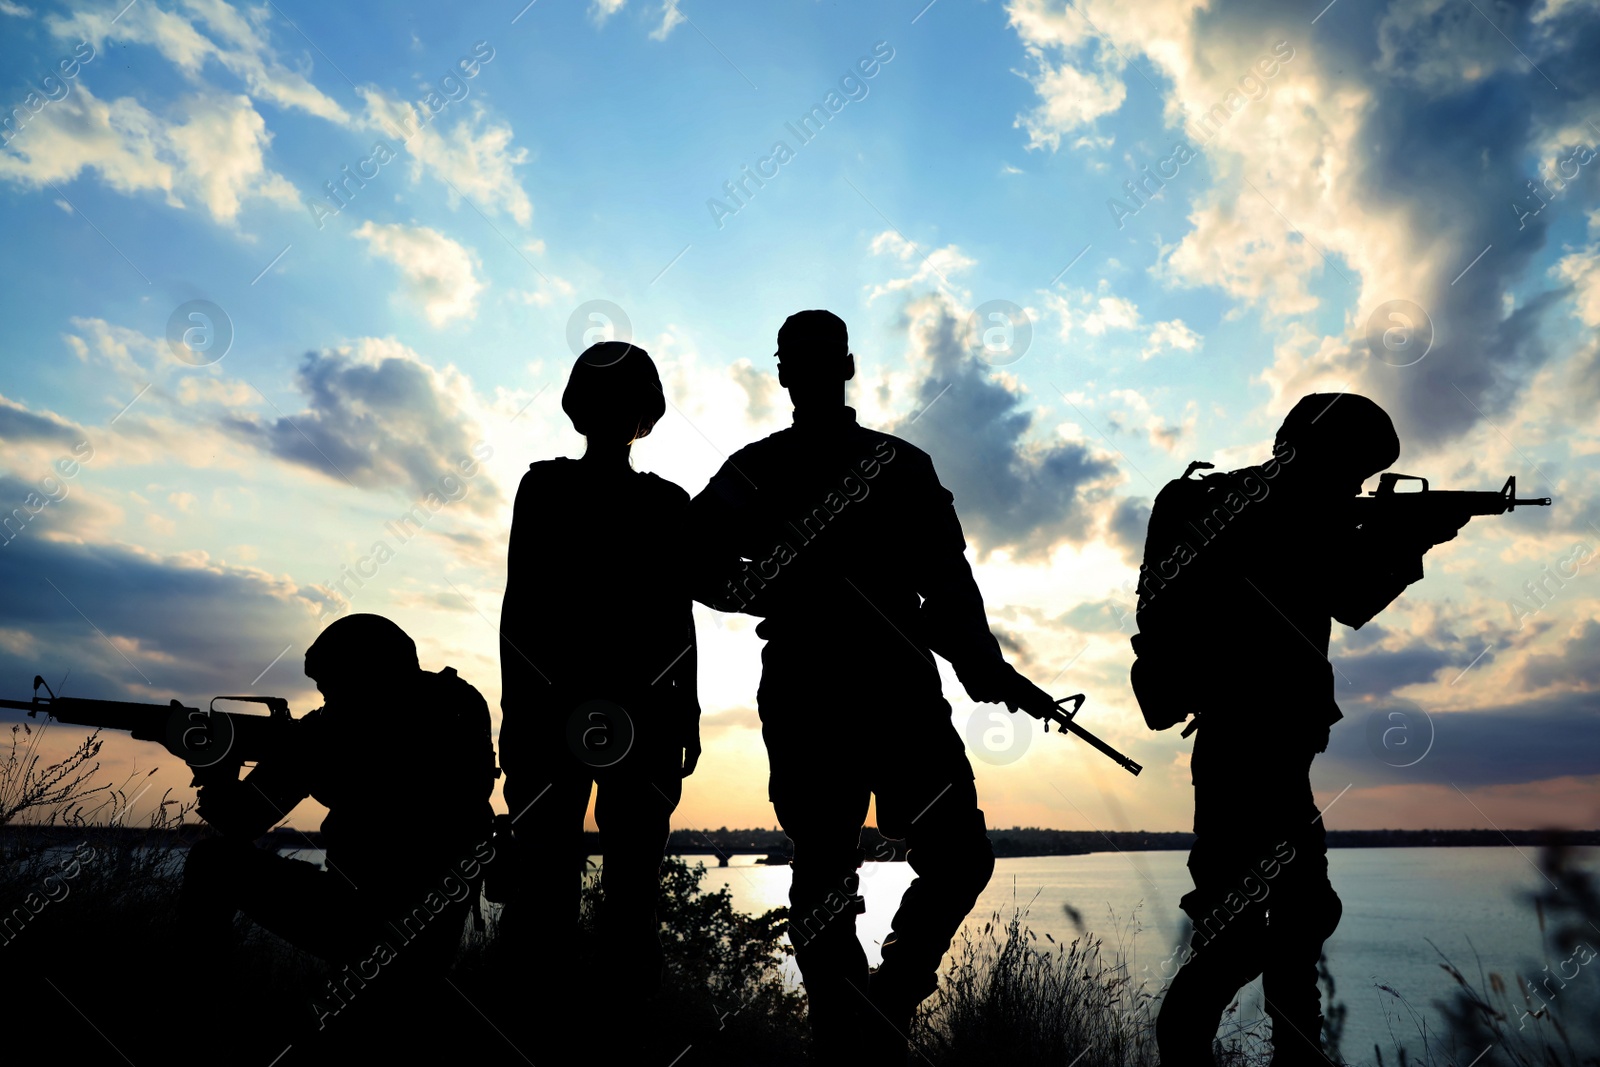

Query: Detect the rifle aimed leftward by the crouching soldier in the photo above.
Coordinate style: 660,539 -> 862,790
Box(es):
0,675 -> 299,785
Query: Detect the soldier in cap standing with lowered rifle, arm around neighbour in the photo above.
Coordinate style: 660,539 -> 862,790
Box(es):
691,310 -> 1050,1064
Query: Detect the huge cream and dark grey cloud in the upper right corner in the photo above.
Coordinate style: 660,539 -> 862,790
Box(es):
1008,0 -> 1600,446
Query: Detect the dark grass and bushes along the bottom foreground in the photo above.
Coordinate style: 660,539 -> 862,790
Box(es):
0,728 -> 1600,1067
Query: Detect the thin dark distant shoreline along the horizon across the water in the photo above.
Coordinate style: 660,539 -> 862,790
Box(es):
9,824 -> 1600,861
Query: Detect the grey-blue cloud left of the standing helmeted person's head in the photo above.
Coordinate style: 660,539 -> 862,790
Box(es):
222,338 -> 501,515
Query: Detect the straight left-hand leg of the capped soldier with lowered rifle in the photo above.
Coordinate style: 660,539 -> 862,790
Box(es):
762,710 -> 870,1064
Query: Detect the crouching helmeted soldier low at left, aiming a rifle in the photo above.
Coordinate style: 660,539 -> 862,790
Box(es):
179,614 -> 494,1027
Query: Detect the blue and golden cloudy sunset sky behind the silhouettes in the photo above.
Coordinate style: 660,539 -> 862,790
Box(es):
0,0 -> 1600,830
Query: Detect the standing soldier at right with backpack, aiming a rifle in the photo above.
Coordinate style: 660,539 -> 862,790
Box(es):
1138,394 -> 1467,1067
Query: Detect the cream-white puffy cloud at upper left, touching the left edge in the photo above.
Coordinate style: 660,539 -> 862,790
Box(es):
0,78 -> 299,224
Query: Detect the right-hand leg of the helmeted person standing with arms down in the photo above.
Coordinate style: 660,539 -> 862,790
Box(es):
595,752 -> 683,998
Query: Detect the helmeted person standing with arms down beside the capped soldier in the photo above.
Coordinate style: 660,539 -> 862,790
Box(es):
499,341 -> 701,998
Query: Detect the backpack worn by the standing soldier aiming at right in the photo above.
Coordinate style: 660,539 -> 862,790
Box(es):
1128,461 -> 1243,737
